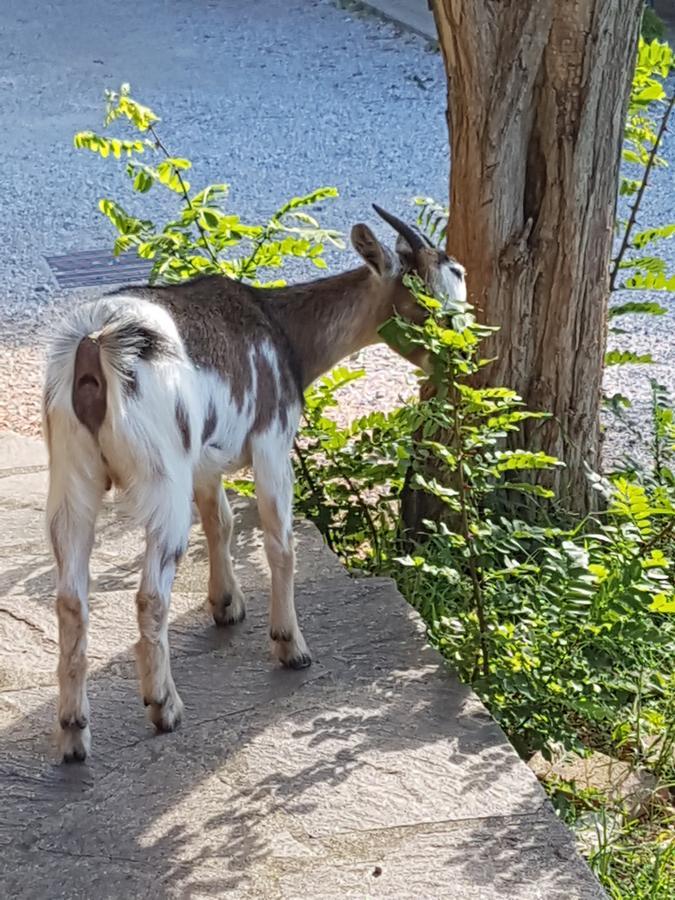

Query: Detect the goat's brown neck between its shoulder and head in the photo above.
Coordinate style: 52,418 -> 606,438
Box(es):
265,266 -> 390,387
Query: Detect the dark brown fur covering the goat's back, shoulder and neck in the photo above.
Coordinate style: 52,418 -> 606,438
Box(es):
108,266 -> 419,410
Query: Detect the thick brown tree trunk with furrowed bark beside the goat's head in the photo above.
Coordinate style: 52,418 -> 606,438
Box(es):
434,0 -> 643,513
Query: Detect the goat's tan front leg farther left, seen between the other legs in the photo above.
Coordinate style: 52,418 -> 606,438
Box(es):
195,472 -> 246,625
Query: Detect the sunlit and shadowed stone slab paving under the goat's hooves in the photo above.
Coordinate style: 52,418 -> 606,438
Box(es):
0,434 -> 604,900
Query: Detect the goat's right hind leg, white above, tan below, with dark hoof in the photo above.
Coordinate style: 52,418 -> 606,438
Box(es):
136,483 -> 191,731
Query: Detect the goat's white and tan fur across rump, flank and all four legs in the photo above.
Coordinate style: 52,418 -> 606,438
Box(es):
44,295 -> 302,759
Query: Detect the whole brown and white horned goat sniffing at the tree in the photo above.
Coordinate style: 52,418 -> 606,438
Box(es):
43,206 -> 466,762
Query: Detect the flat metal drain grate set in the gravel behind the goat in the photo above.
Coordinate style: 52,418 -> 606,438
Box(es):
45,250 -> 152,288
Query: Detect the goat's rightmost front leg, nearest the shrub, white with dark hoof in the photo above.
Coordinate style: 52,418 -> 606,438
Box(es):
253,446 -> 312,669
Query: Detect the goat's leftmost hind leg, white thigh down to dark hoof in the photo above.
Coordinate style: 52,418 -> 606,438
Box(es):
47,415 -> 106,762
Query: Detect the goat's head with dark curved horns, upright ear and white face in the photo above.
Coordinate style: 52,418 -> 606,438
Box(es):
351,204 -> 466,323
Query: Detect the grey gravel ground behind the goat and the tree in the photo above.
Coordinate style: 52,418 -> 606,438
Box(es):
0,0 -> 675,472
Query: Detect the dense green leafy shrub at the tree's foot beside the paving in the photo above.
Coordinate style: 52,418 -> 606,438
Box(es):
297,284 -> 675,755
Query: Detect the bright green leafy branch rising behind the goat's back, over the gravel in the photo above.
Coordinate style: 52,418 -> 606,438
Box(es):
74,84 -> 344,283
